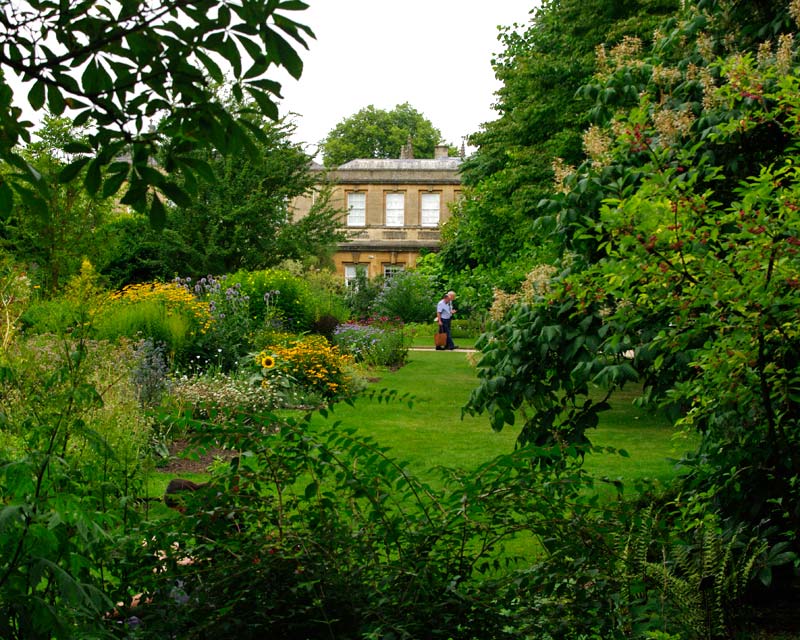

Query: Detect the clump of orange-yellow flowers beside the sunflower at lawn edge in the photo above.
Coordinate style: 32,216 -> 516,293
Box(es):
254,335 -> 355,400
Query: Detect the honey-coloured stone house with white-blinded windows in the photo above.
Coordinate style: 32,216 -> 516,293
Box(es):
293,147 -> 462,279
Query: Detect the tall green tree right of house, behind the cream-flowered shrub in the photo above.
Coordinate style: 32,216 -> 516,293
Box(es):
442,0 -> 678,274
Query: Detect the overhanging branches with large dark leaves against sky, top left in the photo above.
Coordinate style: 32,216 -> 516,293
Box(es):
0,0 -> 313,225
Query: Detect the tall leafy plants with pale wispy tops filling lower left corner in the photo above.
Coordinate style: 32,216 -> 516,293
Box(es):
0,341 -> 148,640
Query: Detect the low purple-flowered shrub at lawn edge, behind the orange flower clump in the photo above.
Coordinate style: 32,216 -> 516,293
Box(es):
333,318 -> 408,367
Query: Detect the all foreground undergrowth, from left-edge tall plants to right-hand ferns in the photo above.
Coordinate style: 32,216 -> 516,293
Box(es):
0,320 -> 785,638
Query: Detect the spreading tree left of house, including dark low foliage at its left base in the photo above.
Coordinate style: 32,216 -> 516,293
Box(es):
101,114 -> 344,283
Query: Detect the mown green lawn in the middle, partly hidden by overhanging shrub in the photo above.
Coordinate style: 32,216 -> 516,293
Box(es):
315,351 -> 691,486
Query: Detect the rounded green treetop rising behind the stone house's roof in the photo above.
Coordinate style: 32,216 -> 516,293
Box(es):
321,102 -> 442,167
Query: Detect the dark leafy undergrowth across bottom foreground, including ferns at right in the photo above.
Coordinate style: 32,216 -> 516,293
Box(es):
109,393 -> 786,640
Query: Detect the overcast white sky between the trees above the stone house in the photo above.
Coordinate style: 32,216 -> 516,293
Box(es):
272,0 -> 538,158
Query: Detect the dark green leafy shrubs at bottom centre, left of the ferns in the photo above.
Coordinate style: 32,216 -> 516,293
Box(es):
109,402 -> 608,640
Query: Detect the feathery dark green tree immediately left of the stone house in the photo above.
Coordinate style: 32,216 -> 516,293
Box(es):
167,117 -> 344,274
